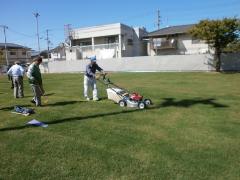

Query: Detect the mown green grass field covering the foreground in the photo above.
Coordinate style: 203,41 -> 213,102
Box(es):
0,73 -> 240,179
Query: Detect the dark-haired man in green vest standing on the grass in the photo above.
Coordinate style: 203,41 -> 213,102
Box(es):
27,57 -> 45,106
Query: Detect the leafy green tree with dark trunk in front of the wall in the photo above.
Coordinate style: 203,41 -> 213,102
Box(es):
190,18 -> 240,72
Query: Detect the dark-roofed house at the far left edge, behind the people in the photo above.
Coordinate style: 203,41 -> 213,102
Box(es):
0,43 -> 31,65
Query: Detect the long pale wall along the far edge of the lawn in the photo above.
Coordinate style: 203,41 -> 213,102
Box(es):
41,54 -> 240,73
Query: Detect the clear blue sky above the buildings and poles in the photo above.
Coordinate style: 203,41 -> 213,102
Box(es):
0,0 -> 240,50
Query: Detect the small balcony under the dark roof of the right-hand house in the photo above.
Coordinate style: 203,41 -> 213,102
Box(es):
153,39 -> 177,49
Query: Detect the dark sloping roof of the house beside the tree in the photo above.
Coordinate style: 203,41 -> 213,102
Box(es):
147,24 -> 195,37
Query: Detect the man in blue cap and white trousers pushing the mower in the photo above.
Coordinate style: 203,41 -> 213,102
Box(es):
84,56 -> 104,101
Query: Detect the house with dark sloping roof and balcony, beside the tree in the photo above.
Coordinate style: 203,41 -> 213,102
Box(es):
146,24 -> 209,56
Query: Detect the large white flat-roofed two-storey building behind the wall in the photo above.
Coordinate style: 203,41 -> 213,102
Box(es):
66,23 -> 147,60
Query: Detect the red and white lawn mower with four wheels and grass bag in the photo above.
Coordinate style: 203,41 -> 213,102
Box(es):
97,74 -> 152,109
